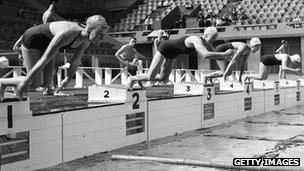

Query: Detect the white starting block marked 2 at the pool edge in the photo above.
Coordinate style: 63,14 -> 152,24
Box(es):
88,85 -> 147,102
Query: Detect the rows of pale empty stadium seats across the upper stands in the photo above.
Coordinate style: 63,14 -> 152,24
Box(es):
112,0 -> 304,32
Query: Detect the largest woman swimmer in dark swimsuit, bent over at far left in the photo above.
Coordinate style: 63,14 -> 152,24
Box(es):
16,15 -> 109,98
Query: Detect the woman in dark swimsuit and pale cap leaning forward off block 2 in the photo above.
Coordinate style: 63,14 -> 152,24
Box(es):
127,27 -> 233,90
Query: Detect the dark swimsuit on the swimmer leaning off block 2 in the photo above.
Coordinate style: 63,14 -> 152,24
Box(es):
157,36 -> 195,59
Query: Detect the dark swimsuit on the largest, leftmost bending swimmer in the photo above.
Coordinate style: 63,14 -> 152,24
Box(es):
21,23 -> 81,52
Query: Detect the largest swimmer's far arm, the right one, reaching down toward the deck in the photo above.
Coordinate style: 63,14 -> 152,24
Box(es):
55,43 -> 90,93
